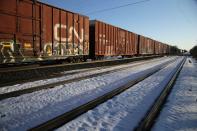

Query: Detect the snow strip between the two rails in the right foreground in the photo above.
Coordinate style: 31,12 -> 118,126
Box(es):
54,56 -> 184,131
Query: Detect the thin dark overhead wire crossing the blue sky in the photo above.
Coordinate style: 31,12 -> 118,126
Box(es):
86,0 -> 150,15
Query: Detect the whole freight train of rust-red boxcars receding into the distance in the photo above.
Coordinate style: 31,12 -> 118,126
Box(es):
0,0 -> 170,64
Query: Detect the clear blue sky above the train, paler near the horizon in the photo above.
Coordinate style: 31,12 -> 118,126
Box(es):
40,0 -> 197,50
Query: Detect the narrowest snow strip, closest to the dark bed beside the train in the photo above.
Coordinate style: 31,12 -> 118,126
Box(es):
0,57 -> 169,94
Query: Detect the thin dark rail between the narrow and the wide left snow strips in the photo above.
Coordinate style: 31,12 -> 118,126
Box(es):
0,56 -> 174,100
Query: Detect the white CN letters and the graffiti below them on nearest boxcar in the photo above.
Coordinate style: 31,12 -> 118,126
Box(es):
44,24 -> 84,56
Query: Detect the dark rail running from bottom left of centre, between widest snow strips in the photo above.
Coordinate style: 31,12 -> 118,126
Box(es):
30,57 -> 180,131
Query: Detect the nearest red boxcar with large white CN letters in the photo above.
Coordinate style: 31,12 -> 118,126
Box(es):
0,0 -> 89,63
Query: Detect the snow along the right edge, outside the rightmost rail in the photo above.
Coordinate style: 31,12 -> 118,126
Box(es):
153,58 -> 197,131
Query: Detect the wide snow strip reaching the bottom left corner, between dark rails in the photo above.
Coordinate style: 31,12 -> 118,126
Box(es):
0,56 -> 180,130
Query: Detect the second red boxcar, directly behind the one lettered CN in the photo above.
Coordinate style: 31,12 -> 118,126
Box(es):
90,20 -> 137,56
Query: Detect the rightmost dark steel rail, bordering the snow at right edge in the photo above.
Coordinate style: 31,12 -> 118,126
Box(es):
135,58 -> 186,131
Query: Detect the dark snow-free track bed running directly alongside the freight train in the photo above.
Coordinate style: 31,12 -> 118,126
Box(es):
0,56 -> 160,87
